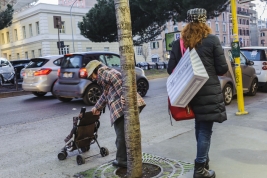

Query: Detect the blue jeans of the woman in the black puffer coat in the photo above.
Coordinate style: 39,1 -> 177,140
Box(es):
195,121 -> 213,163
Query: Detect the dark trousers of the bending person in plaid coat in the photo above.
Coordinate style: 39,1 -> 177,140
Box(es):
114,116 -> 127,163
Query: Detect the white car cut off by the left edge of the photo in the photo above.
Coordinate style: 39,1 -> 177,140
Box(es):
0,58 -> 15,86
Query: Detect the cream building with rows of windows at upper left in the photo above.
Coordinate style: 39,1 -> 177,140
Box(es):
0,4 -> 150,62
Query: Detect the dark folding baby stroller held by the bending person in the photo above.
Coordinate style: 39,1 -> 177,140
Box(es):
58,108 -> 109,165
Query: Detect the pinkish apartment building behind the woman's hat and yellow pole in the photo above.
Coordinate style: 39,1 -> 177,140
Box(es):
150,3 -> 258,61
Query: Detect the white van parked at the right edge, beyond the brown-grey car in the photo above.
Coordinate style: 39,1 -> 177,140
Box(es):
240,46 -> 267,91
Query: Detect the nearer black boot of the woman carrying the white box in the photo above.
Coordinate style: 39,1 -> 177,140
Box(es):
193,161 -> 215,178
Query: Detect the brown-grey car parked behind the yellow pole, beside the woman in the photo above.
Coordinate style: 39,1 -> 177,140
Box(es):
218,47 -> 258,105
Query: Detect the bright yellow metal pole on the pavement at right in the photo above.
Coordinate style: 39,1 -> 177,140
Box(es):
231,0 -> 248,115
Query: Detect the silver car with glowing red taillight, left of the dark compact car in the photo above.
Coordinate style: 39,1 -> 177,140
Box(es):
22,55 -> 63,97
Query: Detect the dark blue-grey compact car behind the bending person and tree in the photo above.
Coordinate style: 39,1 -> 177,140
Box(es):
53,51 -> 149,105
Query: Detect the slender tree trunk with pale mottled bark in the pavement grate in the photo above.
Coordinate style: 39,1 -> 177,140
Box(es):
114,0 -> 142,178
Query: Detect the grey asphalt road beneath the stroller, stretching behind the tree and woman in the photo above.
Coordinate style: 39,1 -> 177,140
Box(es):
0,78 -> 267,178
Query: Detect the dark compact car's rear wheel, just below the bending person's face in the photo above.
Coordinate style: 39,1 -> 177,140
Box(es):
83,84 -> 102,105
